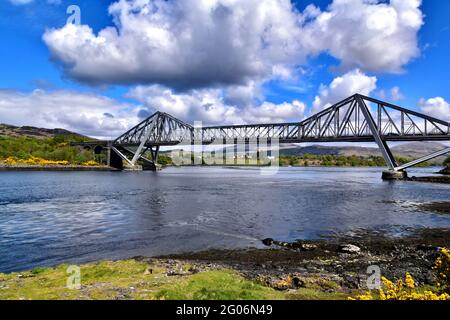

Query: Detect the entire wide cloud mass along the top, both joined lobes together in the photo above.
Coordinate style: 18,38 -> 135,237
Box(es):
43,0 -> 423,89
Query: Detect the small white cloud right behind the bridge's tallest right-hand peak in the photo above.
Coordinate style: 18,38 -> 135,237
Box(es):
313,69 -> 377,113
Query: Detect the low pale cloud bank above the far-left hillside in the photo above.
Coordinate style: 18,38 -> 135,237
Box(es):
0,90 -> 139,139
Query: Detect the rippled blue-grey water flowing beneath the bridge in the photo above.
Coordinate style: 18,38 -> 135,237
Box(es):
0,168 -> 450,272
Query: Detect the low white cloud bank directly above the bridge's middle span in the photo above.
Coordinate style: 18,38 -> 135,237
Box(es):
128,85 -> 306,125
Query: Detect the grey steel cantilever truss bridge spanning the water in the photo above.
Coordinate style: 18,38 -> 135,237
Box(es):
78,94 -> 450,178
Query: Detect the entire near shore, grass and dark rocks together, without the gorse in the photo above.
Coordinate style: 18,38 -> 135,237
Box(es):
0,229 -> 450,300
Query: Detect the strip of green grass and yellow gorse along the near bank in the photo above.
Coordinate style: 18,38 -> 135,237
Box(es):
0,249 -> 450,300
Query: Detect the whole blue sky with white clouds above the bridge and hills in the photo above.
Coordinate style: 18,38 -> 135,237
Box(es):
0,0 -> 450,138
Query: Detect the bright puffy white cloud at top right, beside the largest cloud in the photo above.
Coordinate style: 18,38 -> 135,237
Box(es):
303,0 -> 423,73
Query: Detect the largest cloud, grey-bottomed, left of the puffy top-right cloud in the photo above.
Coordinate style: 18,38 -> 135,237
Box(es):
43,0 -> 304,88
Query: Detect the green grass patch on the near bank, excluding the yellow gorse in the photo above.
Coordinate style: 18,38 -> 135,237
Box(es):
0,260 -> 347,300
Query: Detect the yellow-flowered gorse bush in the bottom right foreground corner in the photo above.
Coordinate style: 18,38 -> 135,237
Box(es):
349,249 -> 450,300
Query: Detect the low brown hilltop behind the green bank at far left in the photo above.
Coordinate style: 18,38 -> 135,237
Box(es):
0,123 -> 86,138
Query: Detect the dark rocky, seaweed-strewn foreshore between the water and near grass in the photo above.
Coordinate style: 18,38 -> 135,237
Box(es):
151,229 -> 450,294
